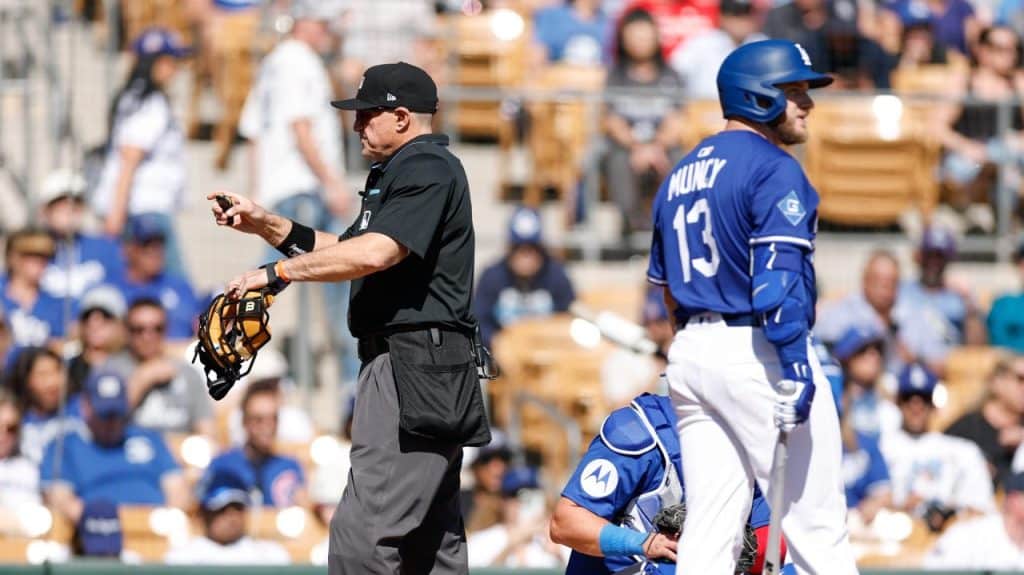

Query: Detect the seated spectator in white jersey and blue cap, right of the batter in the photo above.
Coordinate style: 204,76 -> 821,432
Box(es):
880,363 -> 995,531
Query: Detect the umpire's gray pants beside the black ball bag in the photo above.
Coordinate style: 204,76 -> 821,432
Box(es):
328,353 -> 469,575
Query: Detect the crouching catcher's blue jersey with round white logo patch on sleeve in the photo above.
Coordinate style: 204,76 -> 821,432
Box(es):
562,394 -> 771,575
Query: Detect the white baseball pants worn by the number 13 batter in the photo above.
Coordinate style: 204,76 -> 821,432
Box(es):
667,314 -> 857,575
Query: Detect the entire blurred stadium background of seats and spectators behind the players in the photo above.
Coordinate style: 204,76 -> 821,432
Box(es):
0,0 -> 1024,573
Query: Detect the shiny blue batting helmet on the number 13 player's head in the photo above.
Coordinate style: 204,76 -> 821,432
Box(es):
718,40 -> 833,124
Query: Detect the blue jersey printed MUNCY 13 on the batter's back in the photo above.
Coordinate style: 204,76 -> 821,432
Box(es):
647,130 -> 818,325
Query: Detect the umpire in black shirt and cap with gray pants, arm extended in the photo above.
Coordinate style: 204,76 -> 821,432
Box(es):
210,62 -> 490,575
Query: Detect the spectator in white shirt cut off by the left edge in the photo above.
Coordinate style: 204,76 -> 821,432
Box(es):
0,389 -> 42,535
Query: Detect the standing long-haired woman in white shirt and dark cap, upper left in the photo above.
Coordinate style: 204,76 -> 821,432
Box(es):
92,28 -> 188,275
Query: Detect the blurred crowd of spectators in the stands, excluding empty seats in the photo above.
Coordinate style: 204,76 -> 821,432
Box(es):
6,0 -> 1024,568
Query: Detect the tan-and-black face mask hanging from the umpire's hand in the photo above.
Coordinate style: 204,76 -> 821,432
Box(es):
193,289 -> 273,400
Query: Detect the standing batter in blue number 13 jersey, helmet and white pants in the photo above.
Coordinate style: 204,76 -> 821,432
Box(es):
647,40 -> 857,575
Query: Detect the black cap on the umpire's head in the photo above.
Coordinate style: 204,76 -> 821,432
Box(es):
331,61 -> 437,114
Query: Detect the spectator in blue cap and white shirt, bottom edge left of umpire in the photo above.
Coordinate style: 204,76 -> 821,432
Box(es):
164,473 -> 291,565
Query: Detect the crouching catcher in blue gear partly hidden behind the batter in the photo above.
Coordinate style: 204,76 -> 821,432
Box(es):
551,394 -> 784,575
